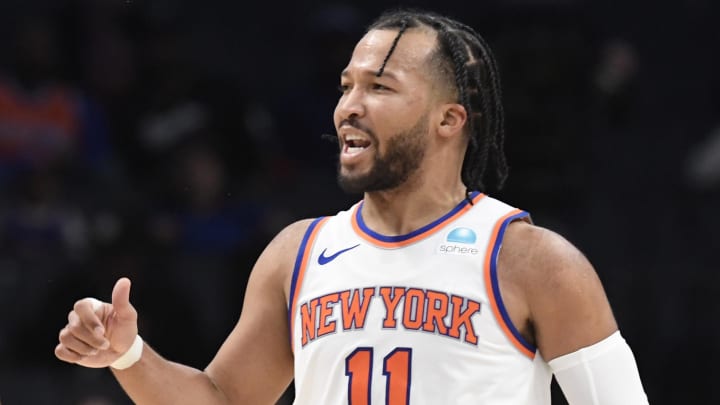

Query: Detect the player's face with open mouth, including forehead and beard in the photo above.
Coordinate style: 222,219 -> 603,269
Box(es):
334,30 -> 435,193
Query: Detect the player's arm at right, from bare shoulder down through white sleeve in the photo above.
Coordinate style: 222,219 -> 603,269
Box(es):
498,222 -> 648,405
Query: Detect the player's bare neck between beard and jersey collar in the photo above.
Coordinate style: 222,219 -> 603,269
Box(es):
362,173 -> 466,236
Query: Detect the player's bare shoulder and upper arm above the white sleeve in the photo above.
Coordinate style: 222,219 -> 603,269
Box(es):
498,221 -> 617,360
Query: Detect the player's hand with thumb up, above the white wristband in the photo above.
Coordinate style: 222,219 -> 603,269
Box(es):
55,277 -> 137,368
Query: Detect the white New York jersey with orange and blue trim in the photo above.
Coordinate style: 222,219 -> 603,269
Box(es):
288,193 -> 552,405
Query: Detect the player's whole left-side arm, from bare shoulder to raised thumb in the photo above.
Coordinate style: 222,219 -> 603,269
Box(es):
55,221 -> 316,405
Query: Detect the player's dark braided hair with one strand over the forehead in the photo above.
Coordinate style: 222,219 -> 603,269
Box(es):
368,10 -> 508,195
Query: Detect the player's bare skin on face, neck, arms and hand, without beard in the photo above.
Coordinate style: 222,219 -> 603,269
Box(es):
55,29 -> 617,404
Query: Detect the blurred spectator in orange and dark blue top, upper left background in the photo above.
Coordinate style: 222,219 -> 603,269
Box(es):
0,16 -> 109,186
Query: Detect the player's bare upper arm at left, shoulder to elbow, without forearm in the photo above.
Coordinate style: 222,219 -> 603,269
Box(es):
201,220 -> 311,404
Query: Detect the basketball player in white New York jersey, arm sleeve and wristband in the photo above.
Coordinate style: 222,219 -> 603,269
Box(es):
55,11 -> 647,405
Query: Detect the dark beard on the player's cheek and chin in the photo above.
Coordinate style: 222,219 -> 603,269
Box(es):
338,116 -> 428,194
